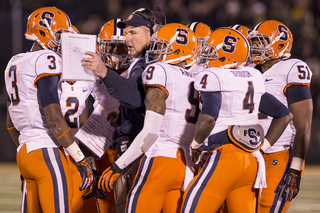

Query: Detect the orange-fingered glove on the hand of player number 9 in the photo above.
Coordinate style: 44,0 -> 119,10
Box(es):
98,163 -> 122,193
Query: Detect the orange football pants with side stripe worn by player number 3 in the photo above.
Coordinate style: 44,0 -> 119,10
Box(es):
17,145 -> 73,213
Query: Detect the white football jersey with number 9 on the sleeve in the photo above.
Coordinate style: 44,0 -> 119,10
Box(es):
142,62 -> 200,158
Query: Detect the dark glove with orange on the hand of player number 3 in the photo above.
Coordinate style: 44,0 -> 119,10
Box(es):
76,158 -> 93,191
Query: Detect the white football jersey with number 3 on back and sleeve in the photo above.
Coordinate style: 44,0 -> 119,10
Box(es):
5,50 -> 62,152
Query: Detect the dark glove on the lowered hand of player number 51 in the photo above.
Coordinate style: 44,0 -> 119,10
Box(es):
276,168 -> 301,202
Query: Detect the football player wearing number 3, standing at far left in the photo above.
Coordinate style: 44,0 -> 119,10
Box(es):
5,7 -> 93,213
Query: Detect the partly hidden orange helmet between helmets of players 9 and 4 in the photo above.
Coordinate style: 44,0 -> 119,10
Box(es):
186,22 -> 212,67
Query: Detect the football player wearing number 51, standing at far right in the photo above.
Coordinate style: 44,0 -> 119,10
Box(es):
248,20 -> 313,213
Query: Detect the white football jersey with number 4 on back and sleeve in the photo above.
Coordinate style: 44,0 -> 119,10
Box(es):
194,67 -> 265,135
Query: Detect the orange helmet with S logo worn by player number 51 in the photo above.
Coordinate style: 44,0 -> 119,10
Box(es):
248,20 -> 293,64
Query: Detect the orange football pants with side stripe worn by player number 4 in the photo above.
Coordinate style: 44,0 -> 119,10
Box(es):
182,144 -> 258,213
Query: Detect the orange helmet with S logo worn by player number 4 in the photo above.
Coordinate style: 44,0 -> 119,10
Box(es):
199,27 -> 249,68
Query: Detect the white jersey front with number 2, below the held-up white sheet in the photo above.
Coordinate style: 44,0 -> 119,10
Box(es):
59,81 -> 95,135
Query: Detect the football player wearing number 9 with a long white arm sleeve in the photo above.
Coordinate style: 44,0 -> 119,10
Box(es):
98,23 -> 200,213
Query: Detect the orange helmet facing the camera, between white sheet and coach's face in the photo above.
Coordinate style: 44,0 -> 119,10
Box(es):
98,18 -> 133,74
